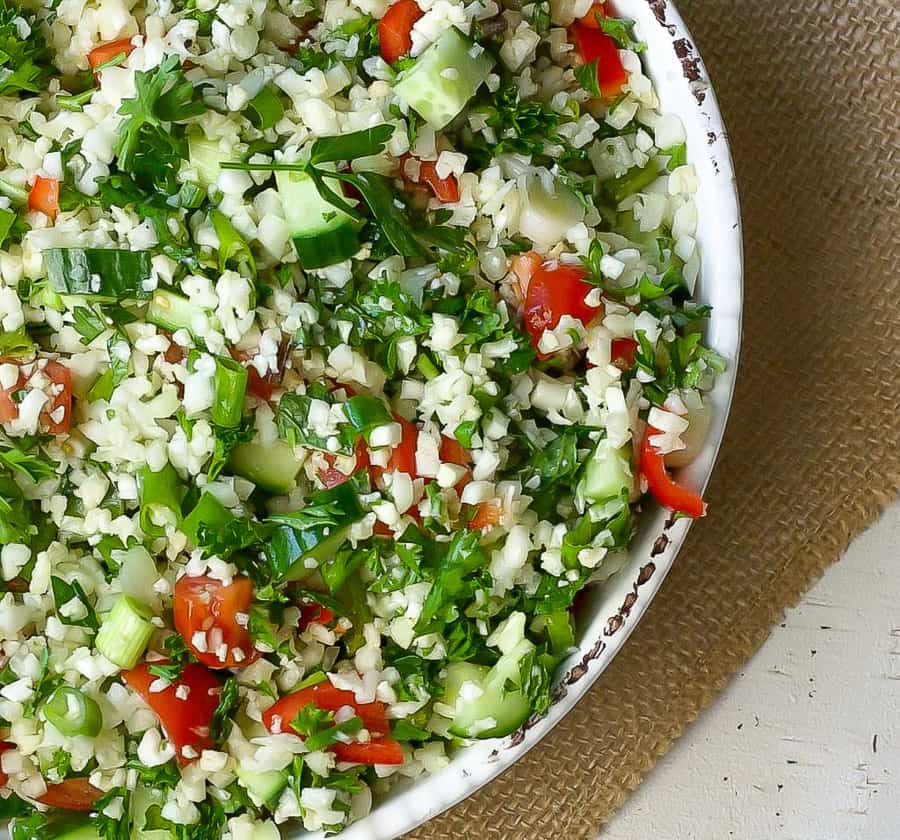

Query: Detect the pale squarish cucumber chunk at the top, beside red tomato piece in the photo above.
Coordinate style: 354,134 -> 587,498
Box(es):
394,26 -> 494,129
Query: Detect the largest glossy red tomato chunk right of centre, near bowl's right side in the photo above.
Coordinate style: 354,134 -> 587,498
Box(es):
524,263 -> 600,359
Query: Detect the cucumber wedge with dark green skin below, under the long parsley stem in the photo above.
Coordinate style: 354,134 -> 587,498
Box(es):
275,166 -> 360,269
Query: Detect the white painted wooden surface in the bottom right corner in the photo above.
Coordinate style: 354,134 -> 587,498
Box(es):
602,503 -> 900,840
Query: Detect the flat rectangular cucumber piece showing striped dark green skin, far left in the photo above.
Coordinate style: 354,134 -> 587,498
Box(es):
44,248 -> 152,301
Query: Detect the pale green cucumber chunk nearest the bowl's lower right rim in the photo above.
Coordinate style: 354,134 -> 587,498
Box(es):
441,639 -> 534,738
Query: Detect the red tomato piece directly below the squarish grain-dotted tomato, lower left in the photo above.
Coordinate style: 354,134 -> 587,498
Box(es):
122,662 -> 222,763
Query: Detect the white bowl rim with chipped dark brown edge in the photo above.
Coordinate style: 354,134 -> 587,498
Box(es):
330,0 -> 743,840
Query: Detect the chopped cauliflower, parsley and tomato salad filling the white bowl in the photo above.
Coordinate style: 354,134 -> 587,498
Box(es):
0,0 -> 724,840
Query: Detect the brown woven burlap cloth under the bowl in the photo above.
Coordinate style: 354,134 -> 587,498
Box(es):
407,0 -> 900,840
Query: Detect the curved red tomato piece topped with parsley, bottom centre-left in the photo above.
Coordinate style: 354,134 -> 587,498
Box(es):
263,682 -> 403,764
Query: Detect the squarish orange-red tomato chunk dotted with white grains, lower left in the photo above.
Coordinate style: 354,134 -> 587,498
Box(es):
172,575 -> 259,668
